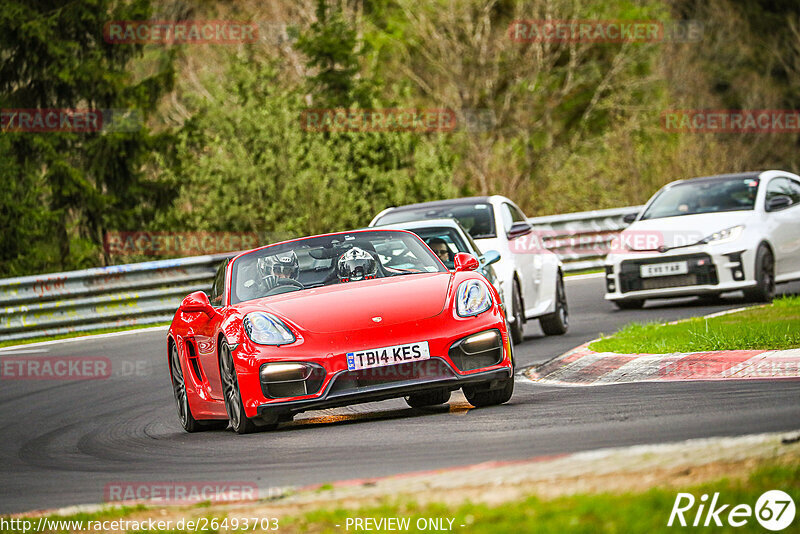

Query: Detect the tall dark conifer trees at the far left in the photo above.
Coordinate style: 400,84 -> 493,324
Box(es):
0,0 -> 174,275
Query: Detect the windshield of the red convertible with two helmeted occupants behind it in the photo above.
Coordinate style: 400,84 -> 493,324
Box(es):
231,230 -> 446,304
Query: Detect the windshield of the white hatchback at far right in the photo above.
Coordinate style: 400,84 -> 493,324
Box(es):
642,177 -> 759,219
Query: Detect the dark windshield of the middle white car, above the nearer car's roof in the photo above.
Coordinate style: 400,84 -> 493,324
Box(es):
376,202 -> 497,239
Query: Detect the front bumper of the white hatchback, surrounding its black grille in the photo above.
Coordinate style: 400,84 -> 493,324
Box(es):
605,244 -> 756,301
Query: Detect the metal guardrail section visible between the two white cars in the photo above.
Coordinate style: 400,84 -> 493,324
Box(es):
528,206 -> 644,272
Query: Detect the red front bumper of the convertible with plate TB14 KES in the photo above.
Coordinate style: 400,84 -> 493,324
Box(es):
234,306 -> 513,418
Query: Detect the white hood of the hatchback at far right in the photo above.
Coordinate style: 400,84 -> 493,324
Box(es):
612,211 -> 753,252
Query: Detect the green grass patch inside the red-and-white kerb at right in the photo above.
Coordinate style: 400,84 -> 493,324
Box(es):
589,297 -> 800,354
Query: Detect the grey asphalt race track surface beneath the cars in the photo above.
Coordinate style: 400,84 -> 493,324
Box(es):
0,278 -> 800,513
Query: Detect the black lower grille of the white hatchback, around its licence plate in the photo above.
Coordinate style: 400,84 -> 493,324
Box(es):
619,254 -> 719,293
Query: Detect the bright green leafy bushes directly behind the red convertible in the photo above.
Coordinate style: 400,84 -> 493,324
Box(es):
153,51 -> 458,242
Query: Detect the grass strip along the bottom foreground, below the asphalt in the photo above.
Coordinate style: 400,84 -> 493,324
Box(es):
0,461 -> 800,534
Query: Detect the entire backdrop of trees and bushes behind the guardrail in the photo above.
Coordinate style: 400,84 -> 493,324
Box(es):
0,0 -> 800,277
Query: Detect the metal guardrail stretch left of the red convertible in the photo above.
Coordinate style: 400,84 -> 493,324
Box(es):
0,253 -> 233,341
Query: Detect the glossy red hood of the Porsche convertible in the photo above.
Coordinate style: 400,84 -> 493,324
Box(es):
239,272 -> 452,333
